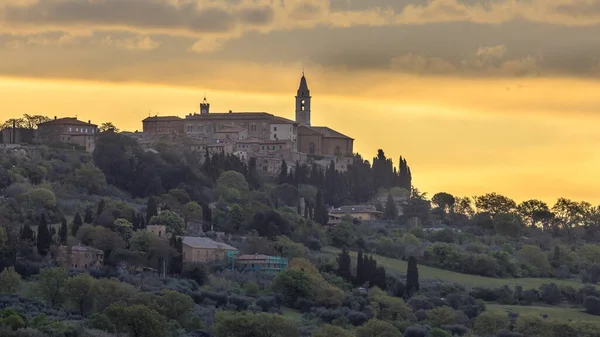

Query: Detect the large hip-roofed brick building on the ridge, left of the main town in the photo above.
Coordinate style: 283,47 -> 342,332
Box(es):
37,116 -> 98,152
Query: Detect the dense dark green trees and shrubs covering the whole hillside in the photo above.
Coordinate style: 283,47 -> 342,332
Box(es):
0,126 -> 600,337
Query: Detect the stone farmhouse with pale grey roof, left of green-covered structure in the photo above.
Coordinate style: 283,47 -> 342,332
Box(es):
182,236 -> 238,263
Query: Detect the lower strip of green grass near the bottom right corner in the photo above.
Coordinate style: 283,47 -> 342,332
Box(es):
486,303 -> 600,323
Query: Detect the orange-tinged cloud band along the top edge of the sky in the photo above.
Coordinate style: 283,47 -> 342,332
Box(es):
5,0 -> 600,37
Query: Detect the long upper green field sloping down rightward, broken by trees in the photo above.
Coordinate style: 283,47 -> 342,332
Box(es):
323,247 -> 583,289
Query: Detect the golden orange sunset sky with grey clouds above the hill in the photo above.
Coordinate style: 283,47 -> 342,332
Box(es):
0,0 -> 600,204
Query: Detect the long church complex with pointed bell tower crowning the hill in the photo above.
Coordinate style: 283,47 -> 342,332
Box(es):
142,73 -> 354,157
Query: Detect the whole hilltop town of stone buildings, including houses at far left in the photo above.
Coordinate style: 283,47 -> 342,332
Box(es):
2,74 -> 354,175
